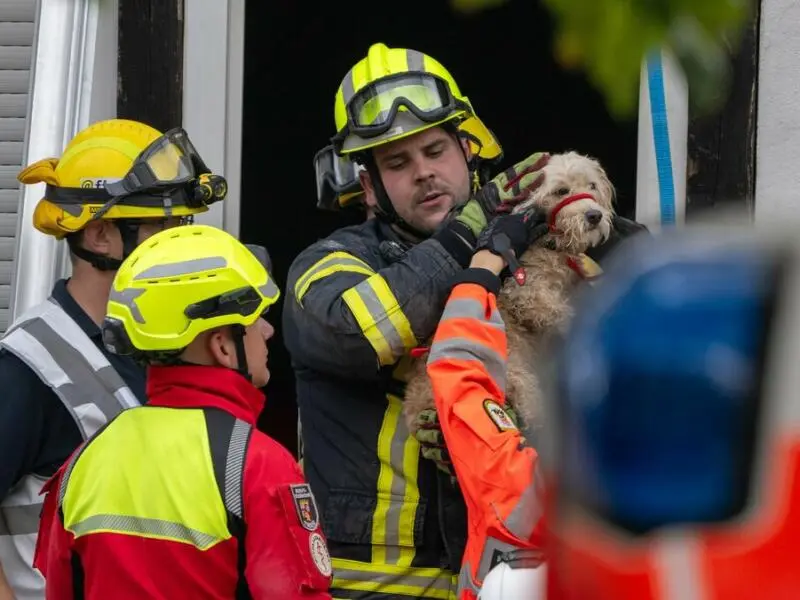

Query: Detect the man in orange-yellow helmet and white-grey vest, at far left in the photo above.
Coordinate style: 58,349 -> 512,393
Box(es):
0,119 -> 225,600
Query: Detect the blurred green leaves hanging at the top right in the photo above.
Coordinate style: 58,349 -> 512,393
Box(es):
450,0 -> 751,118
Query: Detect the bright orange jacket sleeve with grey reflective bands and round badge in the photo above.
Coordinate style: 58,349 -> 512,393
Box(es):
428,269 -> 543,598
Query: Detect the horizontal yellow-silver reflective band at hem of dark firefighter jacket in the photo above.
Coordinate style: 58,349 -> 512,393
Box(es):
331,558 -> 456,600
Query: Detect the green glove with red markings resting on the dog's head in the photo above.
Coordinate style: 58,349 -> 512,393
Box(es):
475,152 -> 550,218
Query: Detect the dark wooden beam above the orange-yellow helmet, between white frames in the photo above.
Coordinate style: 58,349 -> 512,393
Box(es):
117,0 -> 183,131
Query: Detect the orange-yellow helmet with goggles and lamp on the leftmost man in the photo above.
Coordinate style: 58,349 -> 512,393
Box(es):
18,119 -> 227,239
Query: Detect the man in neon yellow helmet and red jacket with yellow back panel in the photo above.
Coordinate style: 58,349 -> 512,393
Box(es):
36,225 -> 331,600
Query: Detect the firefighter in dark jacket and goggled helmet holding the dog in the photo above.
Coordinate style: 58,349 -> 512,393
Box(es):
283,44 -> 546,599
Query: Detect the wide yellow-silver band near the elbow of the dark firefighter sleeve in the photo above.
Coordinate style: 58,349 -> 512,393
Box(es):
342,273 -> 417,366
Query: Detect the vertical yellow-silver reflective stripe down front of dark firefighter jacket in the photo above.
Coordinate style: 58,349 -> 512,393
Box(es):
372,394 -> 419,566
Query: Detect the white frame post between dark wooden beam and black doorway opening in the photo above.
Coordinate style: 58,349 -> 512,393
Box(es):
183,0 -> 245,237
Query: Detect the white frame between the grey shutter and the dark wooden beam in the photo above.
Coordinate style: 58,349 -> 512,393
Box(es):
12,0 -> 118,319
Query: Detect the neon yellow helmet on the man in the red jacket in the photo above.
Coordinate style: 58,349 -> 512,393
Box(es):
103,225 -> 280,355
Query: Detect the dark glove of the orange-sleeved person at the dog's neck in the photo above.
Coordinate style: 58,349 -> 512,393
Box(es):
475,211 -> 547,285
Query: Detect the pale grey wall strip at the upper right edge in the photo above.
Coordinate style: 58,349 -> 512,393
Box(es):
755,0 -> 800,221
